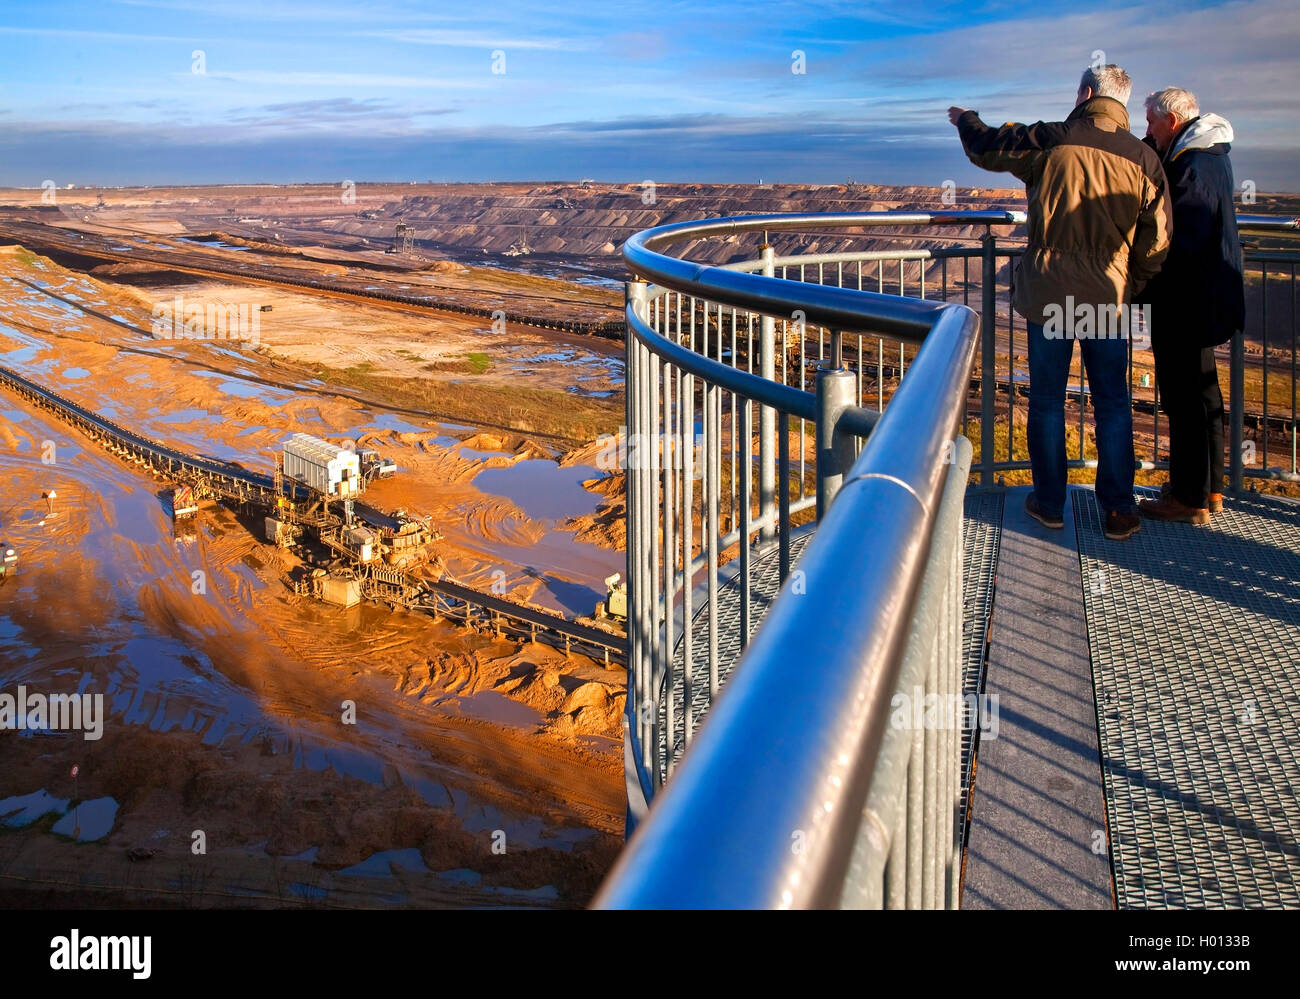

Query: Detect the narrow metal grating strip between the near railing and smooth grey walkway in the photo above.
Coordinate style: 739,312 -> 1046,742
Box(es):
958,489 -> 1006,843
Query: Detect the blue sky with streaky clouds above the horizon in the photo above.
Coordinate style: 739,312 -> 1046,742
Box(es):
0,0 -> 1300,191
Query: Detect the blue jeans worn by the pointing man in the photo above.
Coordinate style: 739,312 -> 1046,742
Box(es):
1028,323 -> 1134,515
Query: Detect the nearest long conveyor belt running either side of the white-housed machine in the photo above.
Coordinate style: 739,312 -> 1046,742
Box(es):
0,367 -> 627,665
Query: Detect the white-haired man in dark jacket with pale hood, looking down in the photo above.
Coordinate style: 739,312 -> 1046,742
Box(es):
1140,87 -> 1245,524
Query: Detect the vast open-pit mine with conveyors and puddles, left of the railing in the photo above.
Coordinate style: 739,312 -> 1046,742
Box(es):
0,182 -> 1289,907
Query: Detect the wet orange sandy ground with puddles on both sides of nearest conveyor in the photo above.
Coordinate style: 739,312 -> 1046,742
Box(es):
0,252 -> 624,905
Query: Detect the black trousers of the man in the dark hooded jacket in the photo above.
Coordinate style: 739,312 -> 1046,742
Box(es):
1152,337 -> 1223,509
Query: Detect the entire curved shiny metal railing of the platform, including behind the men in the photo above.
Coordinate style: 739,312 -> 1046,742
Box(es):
598,211 -> 1296,907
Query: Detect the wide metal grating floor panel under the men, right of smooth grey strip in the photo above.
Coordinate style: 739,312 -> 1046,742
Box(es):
1071,489 -> 1300,908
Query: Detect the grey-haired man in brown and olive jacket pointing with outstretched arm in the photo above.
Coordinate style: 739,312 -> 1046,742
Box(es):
948,65 -> 1170,540
